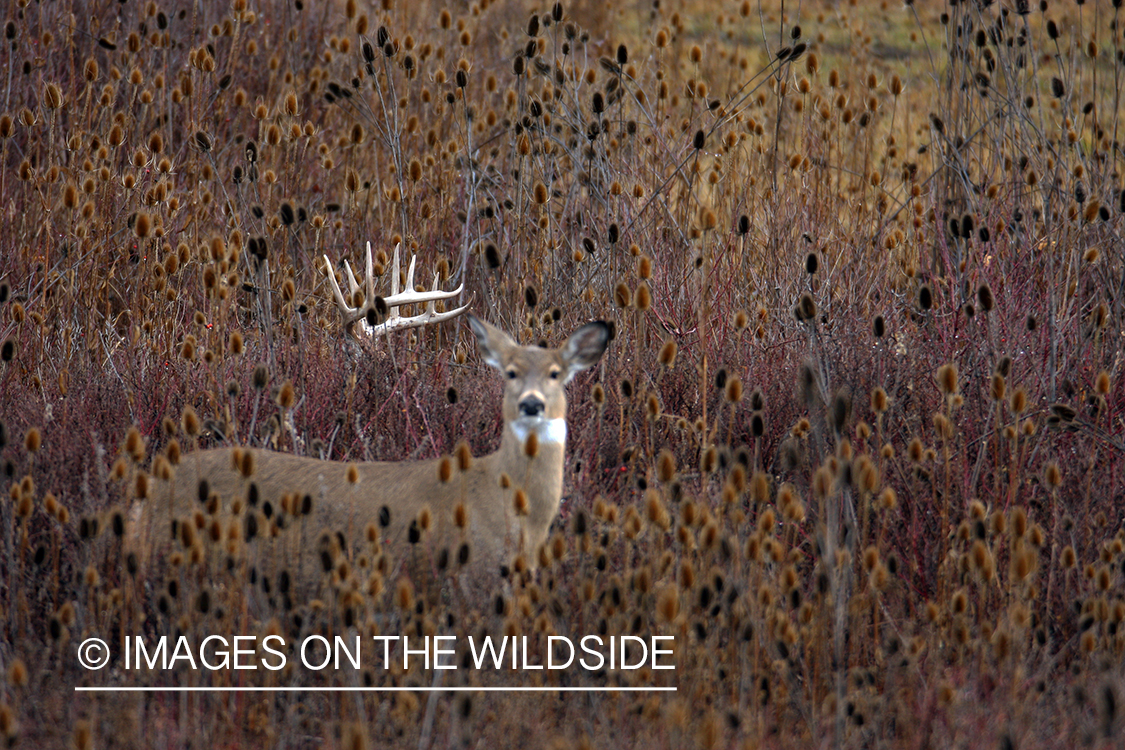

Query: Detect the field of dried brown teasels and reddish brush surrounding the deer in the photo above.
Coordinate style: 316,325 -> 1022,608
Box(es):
0,0 -> 1125,750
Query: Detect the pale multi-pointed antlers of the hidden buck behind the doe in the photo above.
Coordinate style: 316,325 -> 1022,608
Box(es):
324,243 -> 469,338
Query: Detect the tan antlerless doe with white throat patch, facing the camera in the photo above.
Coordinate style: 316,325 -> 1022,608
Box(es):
133,254 -> 609,593
